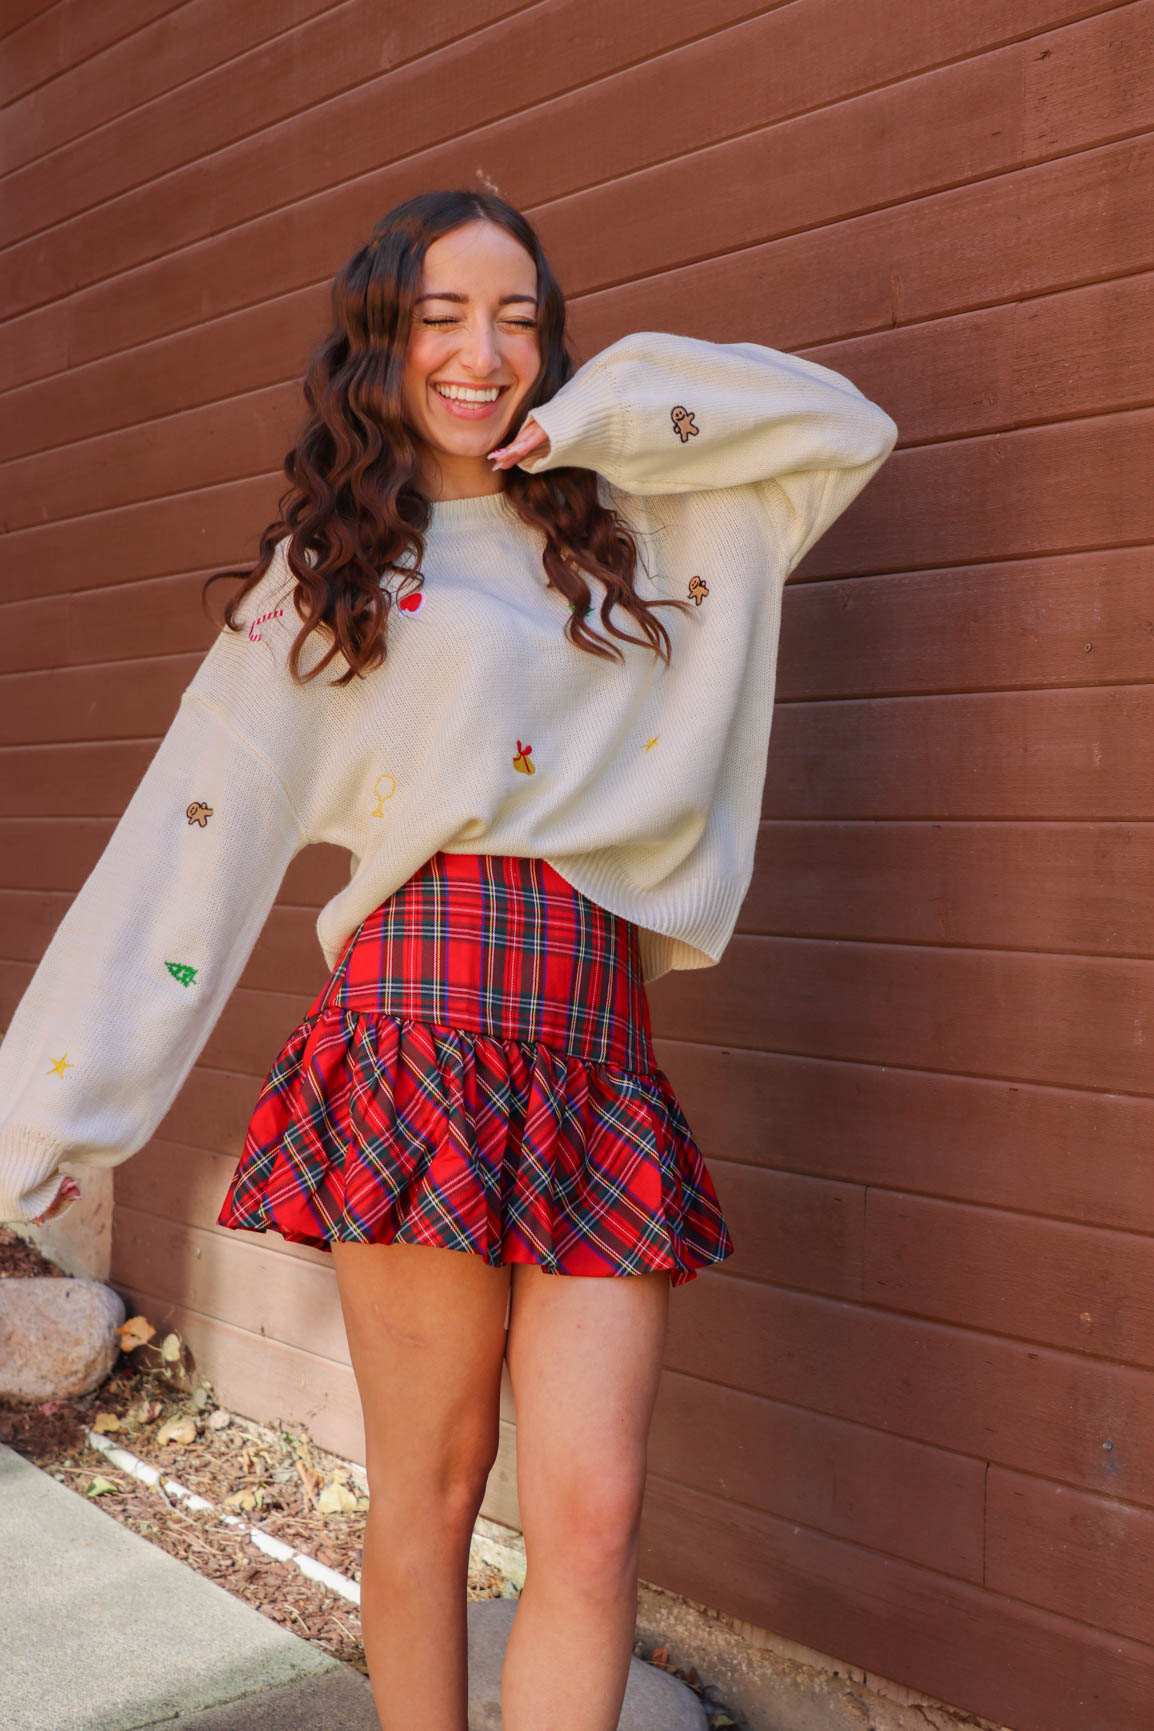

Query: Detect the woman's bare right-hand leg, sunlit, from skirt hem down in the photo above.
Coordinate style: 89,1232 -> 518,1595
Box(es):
502,1264 -> 670,1731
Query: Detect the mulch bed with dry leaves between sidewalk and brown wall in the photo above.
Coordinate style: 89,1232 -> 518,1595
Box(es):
0,1227 -> 737,1731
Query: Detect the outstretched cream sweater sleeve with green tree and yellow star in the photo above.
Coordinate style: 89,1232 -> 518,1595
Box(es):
0,605 -> 306,1222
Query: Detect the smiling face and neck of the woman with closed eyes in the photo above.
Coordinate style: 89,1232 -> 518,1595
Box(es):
401,220 -> 542,499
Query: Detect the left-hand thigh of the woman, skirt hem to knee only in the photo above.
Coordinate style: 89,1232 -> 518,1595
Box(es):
332,1243 -> 509,1501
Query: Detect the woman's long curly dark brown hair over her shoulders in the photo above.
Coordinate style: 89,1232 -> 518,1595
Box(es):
201,189 -> 689,685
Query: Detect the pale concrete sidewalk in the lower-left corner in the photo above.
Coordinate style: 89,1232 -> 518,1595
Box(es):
0,1444 -> 381,1731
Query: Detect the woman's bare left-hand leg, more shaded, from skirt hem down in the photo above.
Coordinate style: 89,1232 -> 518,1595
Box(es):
332,1245 -> 509,1731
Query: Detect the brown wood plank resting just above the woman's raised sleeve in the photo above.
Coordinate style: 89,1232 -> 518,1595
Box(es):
574,137 -> 1154,377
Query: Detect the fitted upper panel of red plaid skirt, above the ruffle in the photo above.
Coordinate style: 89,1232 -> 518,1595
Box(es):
310,852 -> 656,1071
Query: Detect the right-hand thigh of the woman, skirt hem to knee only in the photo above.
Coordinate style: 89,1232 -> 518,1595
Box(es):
507,1264 -> 670,1544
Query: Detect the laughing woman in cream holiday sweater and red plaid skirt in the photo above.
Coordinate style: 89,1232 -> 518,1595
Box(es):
0,192 -> 896,1731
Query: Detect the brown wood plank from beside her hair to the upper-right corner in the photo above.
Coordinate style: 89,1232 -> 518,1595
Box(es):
536,5 -> 1154,294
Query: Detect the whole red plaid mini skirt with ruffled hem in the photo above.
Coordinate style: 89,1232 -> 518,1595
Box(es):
216,853 -> 734,1286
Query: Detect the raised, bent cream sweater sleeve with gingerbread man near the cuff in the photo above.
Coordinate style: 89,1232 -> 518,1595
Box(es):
521,331 -> 898,569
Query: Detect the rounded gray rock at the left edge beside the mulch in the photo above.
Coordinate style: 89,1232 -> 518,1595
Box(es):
0,1276 -> 126,1400
